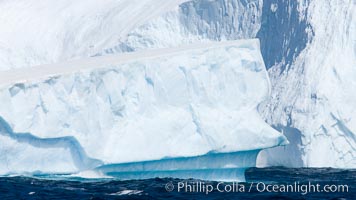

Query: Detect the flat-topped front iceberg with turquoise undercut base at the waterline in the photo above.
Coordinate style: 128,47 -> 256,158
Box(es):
0,39 -> 287,180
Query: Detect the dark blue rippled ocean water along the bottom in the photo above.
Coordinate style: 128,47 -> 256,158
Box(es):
0,167 -> 356,200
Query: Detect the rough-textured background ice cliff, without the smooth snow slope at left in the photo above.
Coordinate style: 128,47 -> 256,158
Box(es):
94,0 -> 356,168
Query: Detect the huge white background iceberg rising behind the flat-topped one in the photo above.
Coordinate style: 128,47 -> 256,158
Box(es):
0,0 -> 356,168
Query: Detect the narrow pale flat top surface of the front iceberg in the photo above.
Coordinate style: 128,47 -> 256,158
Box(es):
0,39 -> 262,86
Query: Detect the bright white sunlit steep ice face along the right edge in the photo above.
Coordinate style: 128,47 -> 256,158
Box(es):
261,0 -> 356,168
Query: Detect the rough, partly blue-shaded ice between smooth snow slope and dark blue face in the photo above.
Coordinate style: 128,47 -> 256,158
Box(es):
98,0 -> 262,55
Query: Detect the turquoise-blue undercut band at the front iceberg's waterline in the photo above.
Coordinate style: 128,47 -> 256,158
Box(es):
94,150 -> 260,182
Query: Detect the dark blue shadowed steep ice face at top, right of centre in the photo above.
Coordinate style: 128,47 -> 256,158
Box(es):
257,0 -> 313,71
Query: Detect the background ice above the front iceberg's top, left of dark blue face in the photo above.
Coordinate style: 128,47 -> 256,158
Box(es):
0,0 -> 262,70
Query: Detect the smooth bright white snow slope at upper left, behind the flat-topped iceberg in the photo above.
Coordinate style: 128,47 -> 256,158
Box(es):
0,0 -> 189,70
